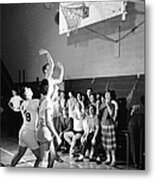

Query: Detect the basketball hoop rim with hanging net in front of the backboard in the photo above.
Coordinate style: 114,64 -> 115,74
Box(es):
60,2 -> 88,37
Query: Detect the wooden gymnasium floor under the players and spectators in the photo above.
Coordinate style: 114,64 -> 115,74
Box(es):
0,138 -> 135,170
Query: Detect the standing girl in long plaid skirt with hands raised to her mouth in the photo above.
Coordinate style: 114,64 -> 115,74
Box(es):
100,91 -> 116,166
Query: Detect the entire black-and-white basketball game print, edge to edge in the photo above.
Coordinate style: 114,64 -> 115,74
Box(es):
0,0 -> 146,171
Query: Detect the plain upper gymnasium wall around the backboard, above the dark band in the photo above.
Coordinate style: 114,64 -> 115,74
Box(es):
1,3 -> 145,82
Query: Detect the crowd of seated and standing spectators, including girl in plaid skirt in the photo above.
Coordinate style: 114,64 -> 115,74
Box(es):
53,89 -> 118,166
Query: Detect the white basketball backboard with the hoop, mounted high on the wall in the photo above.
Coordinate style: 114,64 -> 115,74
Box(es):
59,1 -> 127,35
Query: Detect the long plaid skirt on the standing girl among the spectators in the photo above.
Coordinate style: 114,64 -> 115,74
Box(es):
101,124 -> 116,150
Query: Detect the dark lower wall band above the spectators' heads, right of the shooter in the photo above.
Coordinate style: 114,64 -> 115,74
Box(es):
65,75 -> 145,104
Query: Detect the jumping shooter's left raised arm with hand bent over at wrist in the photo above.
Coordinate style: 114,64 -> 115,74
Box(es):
39,48 -> 55,78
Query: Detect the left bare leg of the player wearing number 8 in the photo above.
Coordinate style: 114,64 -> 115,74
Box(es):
10,146 -> 27,167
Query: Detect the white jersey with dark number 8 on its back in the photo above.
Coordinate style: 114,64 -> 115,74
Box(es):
20,99 -> 39,130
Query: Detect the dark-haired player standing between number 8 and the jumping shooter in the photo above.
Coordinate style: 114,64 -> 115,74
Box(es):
37,79 -> 61,168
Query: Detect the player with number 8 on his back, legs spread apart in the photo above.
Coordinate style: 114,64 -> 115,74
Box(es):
11,87 -> 40,167
